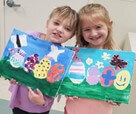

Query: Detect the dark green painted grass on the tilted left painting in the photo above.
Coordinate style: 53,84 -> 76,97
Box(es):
0,59 -> 60,97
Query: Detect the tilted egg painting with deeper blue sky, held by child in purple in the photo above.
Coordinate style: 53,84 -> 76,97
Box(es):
0,29 -> 74,97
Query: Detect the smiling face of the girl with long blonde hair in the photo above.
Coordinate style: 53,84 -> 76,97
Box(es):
81,21 -> 108,48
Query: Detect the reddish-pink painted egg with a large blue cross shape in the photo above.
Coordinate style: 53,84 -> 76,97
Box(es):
100,67 -> 116,87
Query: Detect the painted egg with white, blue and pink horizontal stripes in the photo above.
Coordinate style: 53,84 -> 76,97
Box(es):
69,61 -> 85,84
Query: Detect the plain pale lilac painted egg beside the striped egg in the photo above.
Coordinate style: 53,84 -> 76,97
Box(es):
86,66 -> 101,85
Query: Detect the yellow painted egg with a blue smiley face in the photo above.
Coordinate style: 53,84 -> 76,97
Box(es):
114,70 -> 130,90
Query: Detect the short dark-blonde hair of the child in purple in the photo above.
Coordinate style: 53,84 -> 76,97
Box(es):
49,6 -> 79,32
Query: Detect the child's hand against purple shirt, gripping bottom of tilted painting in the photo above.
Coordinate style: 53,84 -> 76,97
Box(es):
28,88 -> 45,106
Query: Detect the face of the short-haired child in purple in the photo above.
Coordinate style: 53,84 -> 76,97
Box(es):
47,18 -> 74,44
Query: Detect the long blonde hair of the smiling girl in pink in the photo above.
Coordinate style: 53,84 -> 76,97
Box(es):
76,3 -> 117,49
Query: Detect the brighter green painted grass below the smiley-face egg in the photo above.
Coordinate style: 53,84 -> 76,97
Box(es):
59,77 -> 131,104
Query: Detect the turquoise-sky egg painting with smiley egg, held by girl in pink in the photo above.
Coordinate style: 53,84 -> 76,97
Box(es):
59,47 -> 135,104
